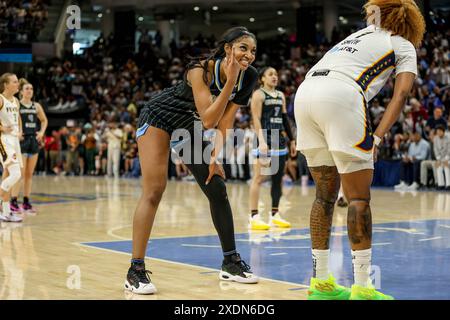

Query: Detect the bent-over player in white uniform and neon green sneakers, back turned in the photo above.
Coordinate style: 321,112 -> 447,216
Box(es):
295,0 -> 425,300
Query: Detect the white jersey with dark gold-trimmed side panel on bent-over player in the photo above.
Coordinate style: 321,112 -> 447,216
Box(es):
307,25 -> 417,101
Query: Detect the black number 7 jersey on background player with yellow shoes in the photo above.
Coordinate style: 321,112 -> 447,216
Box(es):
261,89 -> 285,145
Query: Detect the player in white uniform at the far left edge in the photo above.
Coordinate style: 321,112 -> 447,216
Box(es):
0,73 -> 23,222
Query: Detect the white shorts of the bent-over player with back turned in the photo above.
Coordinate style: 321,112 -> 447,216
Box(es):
295,76 -> 374,173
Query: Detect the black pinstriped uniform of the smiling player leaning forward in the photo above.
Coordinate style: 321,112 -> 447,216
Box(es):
143,59 -> 258,131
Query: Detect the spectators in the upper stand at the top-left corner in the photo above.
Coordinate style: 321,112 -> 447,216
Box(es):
0,0 -> 51,43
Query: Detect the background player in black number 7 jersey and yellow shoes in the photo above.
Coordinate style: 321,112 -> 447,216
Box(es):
249,67 -> 297,230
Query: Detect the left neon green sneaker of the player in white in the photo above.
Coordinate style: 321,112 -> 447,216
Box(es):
308,275 -> 351,300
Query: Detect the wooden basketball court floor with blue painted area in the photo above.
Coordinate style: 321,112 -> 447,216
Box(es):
0,176 -> 450,300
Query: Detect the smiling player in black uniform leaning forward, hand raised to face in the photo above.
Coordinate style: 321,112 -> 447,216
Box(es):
125,27 -> 258,294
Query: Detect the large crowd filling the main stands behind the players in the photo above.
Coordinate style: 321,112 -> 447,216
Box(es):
28,25 -> 450,189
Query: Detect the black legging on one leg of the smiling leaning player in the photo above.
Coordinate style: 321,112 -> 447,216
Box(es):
180,141 -> 236,255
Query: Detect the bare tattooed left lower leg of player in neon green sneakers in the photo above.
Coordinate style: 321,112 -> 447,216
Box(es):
310,166 -> 340,250
